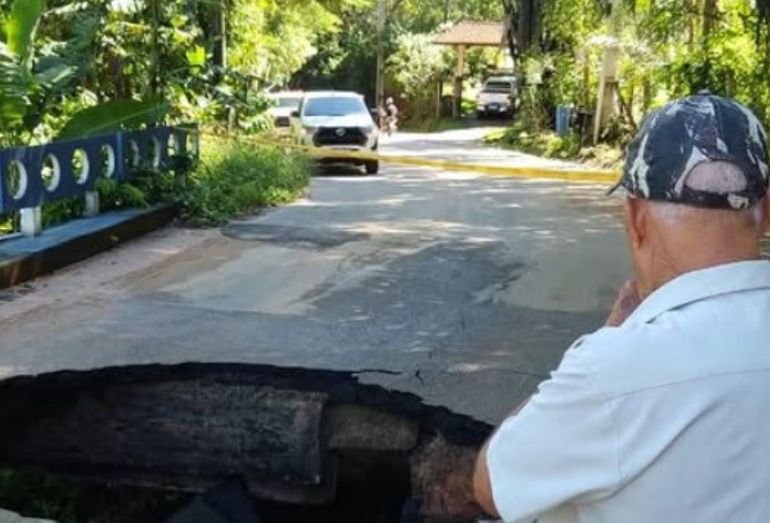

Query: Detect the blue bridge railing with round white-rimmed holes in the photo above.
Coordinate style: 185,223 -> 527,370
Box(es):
0,125 -> 199,236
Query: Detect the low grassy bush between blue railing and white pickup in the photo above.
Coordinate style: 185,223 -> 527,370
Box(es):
178,140 -> 310,226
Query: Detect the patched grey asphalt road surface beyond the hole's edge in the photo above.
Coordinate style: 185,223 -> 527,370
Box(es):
0,129 -> 630,422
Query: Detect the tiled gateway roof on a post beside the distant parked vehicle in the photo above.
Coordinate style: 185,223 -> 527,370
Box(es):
434,22 -> 504,117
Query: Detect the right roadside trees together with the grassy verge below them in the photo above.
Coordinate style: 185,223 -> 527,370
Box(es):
488,0 -> 770,166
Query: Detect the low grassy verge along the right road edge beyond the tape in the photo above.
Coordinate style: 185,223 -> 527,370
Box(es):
484,121 -> 623,169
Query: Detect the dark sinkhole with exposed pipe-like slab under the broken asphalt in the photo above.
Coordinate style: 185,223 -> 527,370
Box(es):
0,363 -> 491,521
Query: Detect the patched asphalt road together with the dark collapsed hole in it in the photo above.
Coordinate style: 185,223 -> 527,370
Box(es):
0,130 -> 629,523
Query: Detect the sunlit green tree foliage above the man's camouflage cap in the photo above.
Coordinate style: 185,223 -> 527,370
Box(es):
522,0 -> 770,146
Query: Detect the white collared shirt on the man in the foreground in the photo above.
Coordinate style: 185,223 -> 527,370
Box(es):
487,261 -> 770,523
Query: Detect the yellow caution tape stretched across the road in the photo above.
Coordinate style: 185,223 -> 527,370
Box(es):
186,129 -> 620,184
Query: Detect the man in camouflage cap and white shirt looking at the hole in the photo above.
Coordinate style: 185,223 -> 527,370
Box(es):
474,93 -> 770,523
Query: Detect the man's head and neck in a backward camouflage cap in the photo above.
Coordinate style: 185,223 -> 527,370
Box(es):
613,94 -> 770,296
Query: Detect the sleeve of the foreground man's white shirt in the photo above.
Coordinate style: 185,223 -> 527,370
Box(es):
487,338 -> 620,523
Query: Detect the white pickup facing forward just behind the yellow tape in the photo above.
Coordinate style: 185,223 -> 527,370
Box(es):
291,91 -> 380,174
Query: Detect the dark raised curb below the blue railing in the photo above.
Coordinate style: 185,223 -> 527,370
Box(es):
0,204 -> 177,289
